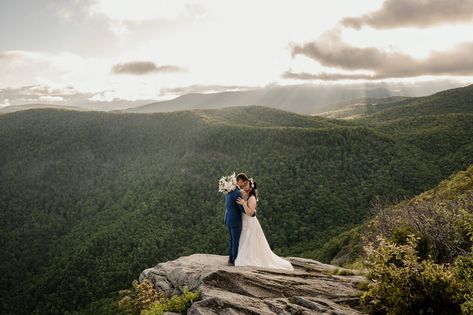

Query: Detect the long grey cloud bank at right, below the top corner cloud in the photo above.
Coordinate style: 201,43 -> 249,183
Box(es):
290,31 -> 473,80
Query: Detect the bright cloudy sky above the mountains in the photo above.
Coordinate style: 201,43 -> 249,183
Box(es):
0,0 -> 473,107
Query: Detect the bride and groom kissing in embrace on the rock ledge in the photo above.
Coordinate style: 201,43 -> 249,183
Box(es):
221,173 -> 294,270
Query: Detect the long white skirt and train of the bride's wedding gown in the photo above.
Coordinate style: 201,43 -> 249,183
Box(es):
235,214 -> 294,270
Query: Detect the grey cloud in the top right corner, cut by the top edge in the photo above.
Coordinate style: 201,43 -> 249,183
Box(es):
341,0 -> 473,29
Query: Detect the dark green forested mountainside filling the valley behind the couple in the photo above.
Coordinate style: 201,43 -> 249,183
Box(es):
0,83 -> 473,314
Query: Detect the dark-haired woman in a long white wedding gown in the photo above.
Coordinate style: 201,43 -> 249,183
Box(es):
235,178 -> 294,270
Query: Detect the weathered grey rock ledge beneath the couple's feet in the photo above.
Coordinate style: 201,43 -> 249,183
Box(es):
140,254 -> 366,315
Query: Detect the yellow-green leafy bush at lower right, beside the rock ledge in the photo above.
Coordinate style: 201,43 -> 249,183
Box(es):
362,236 -> 461,314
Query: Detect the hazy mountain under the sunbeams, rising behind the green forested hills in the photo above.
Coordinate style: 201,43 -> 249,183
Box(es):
123,84 -> 470,118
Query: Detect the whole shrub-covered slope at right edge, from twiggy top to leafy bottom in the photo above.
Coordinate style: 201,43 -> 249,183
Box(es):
362,167 -> 473,314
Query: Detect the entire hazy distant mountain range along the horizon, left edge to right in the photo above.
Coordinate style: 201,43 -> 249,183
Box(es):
0,82 -> 468,118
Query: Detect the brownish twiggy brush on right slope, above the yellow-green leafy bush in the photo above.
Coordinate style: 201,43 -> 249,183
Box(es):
364,190 -> 473,264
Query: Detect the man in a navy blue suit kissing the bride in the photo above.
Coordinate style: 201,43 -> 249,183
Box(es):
225,173 -> 249,266
